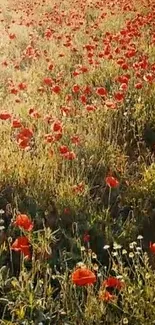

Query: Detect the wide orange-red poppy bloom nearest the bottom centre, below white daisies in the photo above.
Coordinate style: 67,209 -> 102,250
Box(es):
71,268 -> 96,286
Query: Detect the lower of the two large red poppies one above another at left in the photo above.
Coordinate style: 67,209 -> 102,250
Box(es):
11,236 -> 31,258
